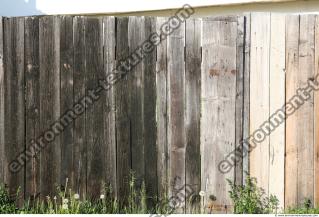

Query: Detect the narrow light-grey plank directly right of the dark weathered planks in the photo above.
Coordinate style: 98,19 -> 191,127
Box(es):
156,17 -> 169,202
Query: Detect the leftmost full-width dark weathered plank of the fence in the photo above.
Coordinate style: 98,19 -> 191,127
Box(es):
4,18 -> 25,202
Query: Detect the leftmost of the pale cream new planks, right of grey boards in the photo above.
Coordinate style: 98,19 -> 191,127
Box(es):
250,13 -> 270,195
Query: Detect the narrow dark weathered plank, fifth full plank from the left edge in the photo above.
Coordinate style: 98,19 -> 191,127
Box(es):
72,16 -> 88,197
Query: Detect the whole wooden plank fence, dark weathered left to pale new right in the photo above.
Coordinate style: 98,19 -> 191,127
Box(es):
0,13 -> 319,212
